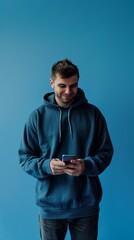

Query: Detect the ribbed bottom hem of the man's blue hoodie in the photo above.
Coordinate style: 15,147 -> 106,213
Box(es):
39,206 -> 99,219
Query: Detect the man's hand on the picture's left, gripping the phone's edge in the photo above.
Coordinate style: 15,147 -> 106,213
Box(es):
50,158 -> 66,175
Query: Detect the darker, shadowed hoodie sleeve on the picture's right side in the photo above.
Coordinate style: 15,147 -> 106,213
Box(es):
83,110 -> 114,176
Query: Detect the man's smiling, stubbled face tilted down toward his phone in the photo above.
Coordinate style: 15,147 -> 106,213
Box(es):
50,74 -> 78,107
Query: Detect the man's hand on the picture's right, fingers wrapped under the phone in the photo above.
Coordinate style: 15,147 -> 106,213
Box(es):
64,159 -> 84,176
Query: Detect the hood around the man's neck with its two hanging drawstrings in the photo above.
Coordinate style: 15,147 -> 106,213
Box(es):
44,88 -> 87,142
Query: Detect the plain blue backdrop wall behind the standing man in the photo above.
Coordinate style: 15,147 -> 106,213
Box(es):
0,0 -> 134,240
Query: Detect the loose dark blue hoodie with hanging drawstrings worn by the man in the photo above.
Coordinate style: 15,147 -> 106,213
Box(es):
19,89 -> 113,219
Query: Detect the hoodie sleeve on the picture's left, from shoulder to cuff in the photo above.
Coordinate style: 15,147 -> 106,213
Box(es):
18,113 -> 52,179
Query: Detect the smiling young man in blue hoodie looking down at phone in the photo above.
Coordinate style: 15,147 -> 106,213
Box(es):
19,59 -> 113,240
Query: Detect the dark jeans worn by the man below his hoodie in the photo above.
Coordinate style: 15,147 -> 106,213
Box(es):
39,215 -> 98,240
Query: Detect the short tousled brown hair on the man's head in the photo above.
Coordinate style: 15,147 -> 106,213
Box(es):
51,58 -> 80,80
